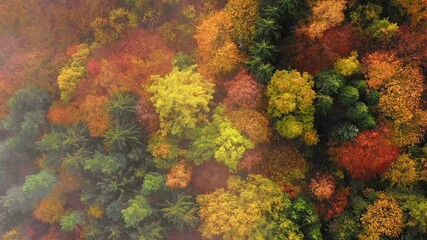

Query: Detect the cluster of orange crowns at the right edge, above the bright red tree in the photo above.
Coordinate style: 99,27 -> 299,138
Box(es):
364,52 -> 427,146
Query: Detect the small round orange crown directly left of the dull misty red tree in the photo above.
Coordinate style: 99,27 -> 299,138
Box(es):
166,160 -> 193,188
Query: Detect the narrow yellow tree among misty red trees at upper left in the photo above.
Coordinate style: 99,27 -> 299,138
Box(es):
57,44 -> 91,103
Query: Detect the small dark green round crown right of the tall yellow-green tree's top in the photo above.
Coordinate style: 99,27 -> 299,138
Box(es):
315,70 -> 345,96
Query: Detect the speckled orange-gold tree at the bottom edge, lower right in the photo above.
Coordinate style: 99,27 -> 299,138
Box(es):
359,193 -> 404,239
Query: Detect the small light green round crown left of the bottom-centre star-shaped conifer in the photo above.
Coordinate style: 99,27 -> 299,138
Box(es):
121,196 -> 152,228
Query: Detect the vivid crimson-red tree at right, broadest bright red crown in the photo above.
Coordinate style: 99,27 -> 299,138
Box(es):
330,126 -> 400,180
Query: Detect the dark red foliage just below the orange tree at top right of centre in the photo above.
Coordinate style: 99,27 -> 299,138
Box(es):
290,24 -> 361,75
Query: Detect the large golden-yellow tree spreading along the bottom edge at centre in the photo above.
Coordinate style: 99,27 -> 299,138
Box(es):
197,175 -> 293,240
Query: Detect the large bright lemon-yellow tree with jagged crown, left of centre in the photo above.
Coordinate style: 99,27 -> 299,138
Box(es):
149,67 -> 214,135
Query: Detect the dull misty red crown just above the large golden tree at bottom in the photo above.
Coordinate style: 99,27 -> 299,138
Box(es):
193,161 -> 230,194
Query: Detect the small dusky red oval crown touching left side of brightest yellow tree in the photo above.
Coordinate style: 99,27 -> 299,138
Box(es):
136,94 -> 160,133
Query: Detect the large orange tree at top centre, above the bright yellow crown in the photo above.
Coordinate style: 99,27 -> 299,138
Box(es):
194,11 -> 243,77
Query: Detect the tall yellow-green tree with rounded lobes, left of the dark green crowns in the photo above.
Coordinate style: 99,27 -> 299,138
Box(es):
267,70 -> 318,145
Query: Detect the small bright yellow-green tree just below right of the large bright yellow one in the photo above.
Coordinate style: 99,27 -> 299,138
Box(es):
214,121 -> 254,172
